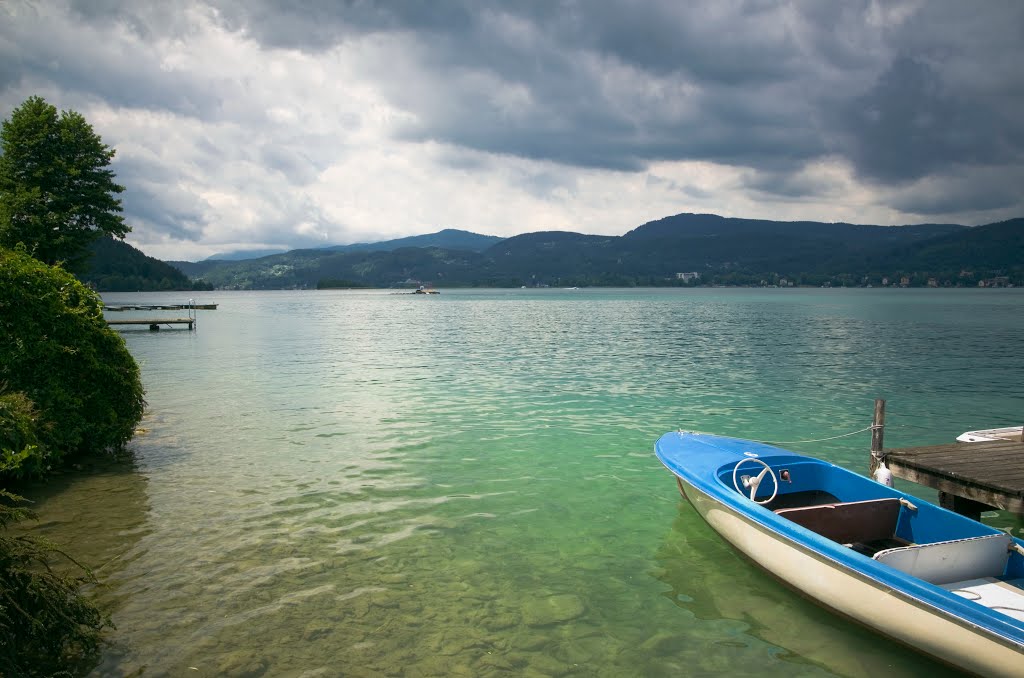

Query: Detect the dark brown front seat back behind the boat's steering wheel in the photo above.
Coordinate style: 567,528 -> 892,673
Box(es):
775,498 -> 900,544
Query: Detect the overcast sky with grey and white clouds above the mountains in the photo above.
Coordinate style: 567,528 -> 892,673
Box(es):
0,0 -> 1024,259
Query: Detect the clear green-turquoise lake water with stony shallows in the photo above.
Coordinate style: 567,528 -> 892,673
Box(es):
22,289 -> 1024,676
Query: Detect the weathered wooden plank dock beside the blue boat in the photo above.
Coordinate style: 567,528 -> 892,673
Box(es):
885,440 -> 1024,520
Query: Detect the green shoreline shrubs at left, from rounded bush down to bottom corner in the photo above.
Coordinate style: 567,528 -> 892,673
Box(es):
0,248 -> 145,676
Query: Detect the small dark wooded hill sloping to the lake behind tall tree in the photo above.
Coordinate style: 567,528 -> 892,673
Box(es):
79,238 -> 213,292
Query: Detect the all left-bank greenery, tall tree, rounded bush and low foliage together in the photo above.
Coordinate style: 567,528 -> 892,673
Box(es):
0,96 -> 145,676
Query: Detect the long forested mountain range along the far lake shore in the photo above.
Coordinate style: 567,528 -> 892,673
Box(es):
86,214 -> 1024,289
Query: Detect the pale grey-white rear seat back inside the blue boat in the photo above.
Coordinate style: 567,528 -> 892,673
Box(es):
874,533 -> 1013,585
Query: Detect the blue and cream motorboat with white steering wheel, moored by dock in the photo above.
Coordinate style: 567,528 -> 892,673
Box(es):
655,432 -> 1024,676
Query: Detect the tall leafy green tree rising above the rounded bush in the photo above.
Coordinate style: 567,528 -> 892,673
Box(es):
0,96 -> 131,270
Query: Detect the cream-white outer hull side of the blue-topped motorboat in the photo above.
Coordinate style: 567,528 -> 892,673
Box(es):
677,475 -> 1024,678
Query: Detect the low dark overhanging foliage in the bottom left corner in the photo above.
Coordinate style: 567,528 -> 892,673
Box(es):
0,489 -> 112,677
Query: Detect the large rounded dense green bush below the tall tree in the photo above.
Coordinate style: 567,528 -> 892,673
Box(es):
0,248 -> 145,471
